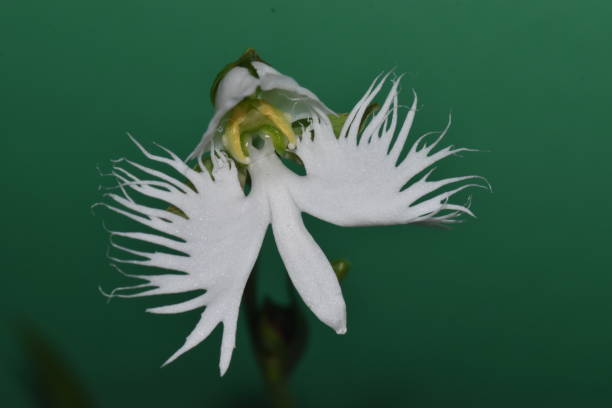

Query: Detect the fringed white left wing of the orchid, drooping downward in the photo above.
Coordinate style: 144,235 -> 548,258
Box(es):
102,135 -> 269,375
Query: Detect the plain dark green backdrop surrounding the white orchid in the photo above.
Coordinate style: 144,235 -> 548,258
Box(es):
0,0 -> 612,407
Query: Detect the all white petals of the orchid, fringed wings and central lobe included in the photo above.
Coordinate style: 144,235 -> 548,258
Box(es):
102,67 -> 481,375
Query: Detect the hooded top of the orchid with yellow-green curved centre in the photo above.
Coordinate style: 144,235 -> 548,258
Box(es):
187,49 -> 334,164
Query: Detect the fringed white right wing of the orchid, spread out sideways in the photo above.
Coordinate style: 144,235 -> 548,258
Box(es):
291,75 -> 488,226
